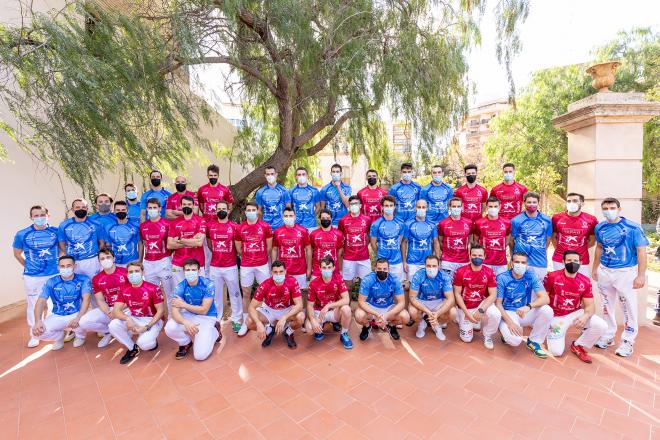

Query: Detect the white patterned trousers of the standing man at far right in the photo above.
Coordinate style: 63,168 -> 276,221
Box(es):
598,265 -> 639,344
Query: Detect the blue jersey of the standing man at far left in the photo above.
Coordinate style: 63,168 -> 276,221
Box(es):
13,225 -> 59,277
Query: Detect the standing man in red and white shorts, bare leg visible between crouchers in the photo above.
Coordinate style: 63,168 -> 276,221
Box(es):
234,201 -> 273,336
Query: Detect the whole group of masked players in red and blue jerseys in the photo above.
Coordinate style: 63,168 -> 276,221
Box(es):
13,163 -> 648,364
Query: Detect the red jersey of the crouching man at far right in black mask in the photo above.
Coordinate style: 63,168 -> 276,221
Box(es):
543,270 -> 594,316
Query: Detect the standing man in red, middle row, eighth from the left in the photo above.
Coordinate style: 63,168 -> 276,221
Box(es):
271,206 -> 312,290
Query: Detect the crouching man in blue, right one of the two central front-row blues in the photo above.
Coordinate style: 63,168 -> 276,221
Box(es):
408,253 -> 455,341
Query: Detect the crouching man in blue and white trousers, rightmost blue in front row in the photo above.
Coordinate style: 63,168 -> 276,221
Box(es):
495,251 -> 554,359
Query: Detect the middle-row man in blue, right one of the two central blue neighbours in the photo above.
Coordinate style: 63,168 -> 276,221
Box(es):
401,199 -> 440,281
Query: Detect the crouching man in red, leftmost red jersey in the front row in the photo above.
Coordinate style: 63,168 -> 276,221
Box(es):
78,248 -> 128,348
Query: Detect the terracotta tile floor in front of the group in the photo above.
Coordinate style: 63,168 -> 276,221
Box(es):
0,320 -> 660,440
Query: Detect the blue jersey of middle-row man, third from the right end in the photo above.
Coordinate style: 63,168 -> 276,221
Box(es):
511,211 -> 552,267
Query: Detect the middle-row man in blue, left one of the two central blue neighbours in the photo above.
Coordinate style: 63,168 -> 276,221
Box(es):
369,196 -> 405,281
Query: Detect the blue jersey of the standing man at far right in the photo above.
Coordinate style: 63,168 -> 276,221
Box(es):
595,217 -> 649,269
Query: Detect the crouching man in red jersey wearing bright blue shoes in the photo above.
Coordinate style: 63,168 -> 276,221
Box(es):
306,256 -> 353,350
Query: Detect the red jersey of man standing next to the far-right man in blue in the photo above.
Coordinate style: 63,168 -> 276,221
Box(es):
552,212 -> 598,264
